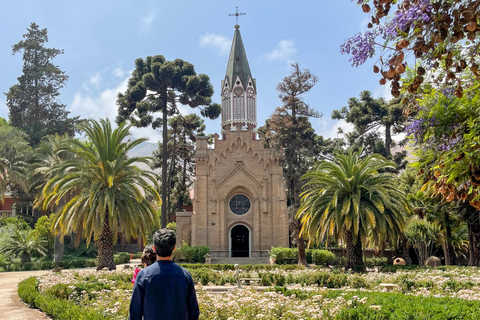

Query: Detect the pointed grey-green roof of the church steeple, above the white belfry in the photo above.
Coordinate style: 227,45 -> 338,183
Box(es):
225,24 -> 253,90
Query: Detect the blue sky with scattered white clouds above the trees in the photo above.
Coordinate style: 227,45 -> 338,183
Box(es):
0,0 -> 391,142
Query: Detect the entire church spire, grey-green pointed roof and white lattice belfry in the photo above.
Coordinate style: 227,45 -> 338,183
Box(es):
222,22 -> 257,129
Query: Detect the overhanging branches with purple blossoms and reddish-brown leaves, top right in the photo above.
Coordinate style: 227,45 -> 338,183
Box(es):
341,0 -> 480,97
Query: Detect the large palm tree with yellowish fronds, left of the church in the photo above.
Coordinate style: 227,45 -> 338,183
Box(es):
42,120 -> 160,270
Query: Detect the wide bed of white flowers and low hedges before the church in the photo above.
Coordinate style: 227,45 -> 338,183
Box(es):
19,268 -> 480,320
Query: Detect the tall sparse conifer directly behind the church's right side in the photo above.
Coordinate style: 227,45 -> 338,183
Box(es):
260,63 -> 320,265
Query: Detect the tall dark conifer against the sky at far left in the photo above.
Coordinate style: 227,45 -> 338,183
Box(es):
6,22 -> 79,146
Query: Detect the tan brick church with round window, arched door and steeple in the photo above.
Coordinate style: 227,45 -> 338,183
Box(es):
176,23 -> 289,258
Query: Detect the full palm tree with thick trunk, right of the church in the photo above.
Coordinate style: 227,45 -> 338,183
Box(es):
297,150 -> 409,270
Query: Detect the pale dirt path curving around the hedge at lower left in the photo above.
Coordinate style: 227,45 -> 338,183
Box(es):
0,259 -> 140,320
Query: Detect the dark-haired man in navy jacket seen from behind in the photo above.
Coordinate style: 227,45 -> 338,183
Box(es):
130,229 -> 200,320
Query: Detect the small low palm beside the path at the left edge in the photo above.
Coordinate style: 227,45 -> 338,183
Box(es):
0,229 -> 46,263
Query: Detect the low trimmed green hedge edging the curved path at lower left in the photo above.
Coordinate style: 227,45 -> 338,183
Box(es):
18,277 -> 107,320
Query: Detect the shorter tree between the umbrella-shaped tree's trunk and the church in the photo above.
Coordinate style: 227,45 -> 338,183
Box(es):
152,113 -> 205,220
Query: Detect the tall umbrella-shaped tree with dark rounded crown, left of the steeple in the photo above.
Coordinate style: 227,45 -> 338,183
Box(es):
117,55 -> 221,228
